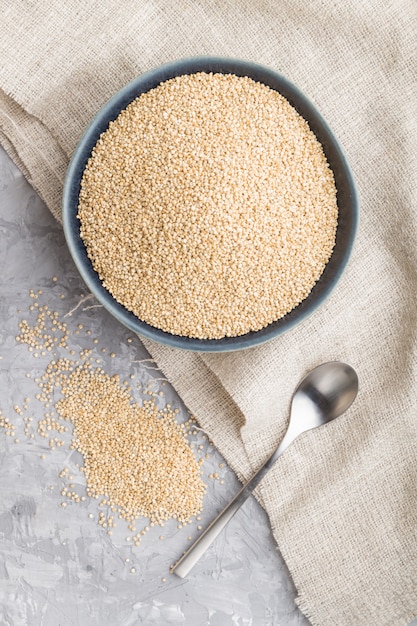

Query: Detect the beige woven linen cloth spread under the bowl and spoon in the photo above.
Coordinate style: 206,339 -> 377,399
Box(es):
0,0 -> 417,626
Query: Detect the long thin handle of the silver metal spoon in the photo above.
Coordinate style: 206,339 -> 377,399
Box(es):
172,442 -> 286,578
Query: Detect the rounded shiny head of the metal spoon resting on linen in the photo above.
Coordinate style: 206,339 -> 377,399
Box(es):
294,361 -> 359,426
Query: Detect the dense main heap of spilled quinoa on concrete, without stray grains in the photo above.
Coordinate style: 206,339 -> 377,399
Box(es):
50,362 -> 206,520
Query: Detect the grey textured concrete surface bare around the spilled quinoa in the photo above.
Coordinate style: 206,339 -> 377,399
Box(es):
0,144 -> 306,626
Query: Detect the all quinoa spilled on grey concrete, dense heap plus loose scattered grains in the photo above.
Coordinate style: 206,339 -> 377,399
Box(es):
12,290 -> 206,528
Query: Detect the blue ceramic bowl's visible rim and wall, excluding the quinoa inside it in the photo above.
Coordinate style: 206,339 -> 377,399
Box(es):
62,57 -> 358,352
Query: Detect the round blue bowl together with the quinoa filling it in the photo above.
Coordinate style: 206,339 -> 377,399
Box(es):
63,57 -> 357,351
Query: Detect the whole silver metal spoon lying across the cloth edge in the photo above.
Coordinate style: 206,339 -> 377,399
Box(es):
172,361 -> 358,578
